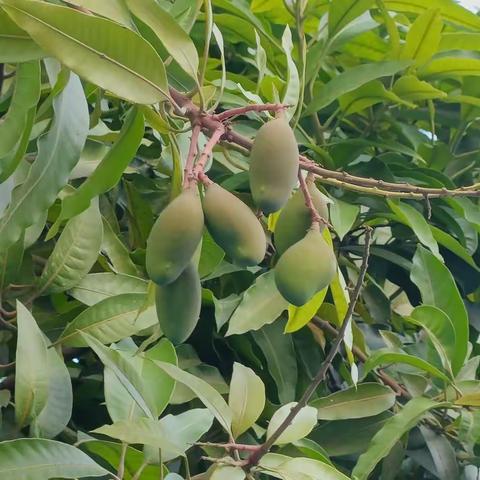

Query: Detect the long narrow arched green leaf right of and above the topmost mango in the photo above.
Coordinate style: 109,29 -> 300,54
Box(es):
304,60 -> 411,115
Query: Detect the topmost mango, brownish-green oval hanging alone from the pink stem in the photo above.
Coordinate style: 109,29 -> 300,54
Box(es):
250,118 -> 298,214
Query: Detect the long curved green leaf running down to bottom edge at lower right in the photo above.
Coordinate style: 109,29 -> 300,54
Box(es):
352,397 -> 448,480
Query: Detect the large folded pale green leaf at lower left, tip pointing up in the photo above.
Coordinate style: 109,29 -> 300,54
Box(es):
15,302 -> 73,437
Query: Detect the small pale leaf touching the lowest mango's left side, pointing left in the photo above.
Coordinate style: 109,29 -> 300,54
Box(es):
69,272 -> 148,306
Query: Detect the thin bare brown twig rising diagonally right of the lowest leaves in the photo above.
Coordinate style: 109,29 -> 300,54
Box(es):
248,226 -> 372,467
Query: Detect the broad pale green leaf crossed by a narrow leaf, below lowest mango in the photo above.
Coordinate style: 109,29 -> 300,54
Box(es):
104,338 -> 177,422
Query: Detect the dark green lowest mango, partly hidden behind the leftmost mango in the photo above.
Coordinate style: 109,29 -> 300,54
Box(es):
155,262 -> 202,344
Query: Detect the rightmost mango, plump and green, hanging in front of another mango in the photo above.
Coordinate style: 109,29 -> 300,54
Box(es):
275,228 -> 337,307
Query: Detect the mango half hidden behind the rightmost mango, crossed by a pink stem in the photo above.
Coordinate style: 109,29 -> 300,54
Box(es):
274,181 -> 328,255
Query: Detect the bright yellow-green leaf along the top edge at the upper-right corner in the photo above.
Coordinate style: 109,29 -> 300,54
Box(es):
384,0 -> 480,30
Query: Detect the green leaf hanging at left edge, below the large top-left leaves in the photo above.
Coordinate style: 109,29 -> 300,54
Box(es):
0,61 -> 41,158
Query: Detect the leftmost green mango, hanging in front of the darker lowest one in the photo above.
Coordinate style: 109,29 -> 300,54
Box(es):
146,187 -> 203,285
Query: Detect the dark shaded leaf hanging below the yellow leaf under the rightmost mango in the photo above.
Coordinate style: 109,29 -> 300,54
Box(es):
253,320 -> 298,403
